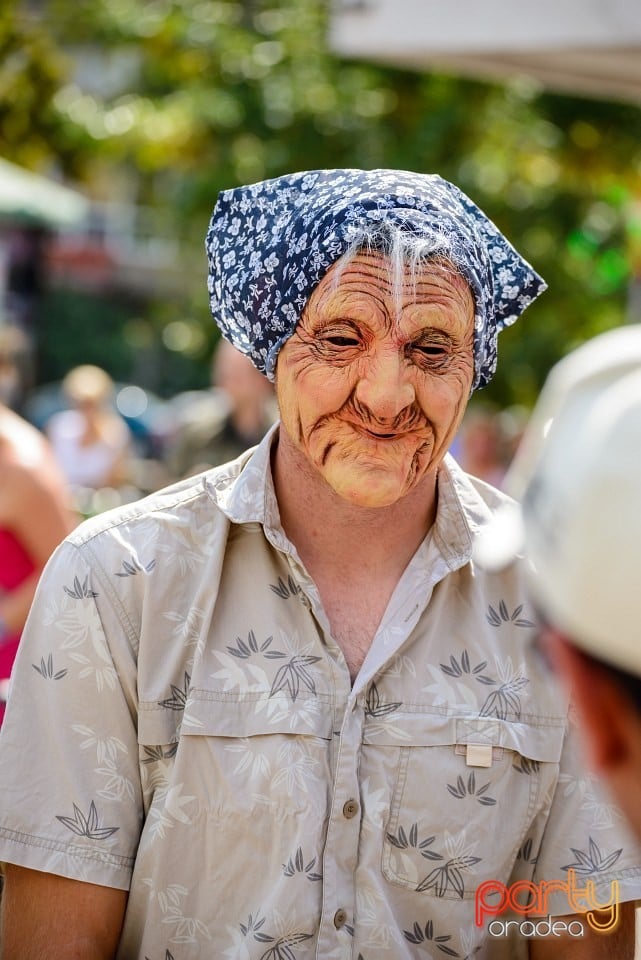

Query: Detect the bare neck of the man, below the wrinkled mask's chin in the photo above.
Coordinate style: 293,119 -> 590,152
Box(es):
273,427 -> 436,572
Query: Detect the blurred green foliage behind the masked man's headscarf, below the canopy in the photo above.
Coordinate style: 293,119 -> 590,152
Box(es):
0,0 -> 641,405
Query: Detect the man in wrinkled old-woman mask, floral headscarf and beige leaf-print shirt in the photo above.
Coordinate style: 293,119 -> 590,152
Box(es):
0,170 -> 641,960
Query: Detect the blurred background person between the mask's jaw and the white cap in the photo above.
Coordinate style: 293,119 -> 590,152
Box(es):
456,404 -> 505,490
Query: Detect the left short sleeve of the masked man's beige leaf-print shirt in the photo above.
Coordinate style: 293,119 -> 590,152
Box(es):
0,542 -> 142,890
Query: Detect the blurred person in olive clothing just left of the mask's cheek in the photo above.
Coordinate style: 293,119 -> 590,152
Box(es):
167,339 -> 277,477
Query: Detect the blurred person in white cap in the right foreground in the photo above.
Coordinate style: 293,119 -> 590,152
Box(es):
480,326 -> 641,835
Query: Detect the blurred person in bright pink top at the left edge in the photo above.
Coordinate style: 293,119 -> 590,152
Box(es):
0,403 -> 74,722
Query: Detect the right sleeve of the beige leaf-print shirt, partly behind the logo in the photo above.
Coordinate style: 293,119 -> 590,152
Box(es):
527,710 -> 641,916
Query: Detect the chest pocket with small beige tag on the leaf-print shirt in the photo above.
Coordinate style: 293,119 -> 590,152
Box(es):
376,715 -> 565,899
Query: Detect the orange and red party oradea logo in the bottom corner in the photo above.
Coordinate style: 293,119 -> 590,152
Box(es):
474,869 -> 619,938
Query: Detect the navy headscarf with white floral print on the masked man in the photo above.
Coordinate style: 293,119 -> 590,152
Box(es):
206,169 -> 546,387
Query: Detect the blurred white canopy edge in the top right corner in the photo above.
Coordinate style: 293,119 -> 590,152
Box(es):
329,0 -> 641,103
